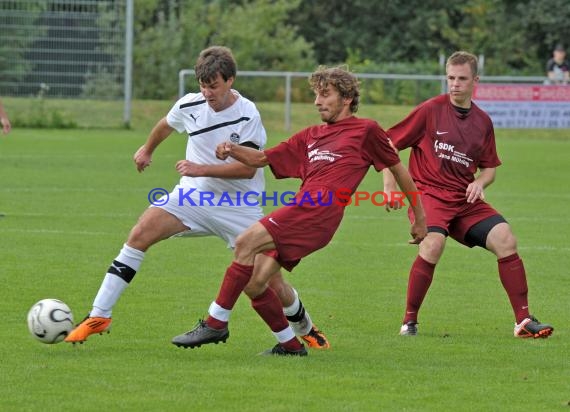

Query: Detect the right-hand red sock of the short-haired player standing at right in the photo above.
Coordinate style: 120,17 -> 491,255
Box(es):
497,253 -> 530,323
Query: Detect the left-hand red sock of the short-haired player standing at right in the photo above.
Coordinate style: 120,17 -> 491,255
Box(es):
404,255 -> 435,323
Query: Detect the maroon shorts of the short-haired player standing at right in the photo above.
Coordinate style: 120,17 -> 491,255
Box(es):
408,187 -> 500,247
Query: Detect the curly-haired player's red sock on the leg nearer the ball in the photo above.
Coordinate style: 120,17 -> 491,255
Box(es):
206,261 -> 253,329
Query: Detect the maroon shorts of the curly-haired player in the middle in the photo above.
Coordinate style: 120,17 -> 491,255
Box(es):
259,192 -> 344,272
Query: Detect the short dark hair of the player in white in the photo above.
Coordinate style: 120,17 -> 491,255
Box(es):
194,46 -> 237,83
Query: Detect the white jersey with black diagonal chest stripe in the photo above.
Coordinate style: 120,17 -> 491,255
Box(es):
166,90 -> 267,199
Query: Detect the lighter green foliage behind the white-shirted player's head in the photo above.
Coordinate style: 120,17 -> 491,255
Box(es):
135,0 -> 314,99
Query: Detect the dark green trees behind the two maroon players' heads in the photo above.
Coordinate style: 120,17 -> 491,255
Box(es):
291,0 -> 570,75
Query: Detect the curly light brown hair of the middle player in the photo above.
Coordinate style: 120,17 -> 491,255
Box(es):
309,66 -> 360,113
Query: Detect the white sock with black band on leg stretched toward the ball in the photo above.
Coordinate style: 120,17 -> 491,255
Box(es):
89,244 -> 144,318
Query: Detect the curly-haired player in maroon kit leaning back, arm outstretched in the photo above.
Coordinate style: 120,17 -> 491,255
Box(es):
172,67 -> 427,356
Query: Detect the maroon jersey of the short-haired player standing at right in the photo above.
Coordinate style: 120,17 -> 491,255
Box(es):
388,95 -> 501,195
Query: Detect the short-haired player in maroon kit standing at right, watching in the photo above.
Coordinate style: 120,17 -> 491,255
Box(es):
384,51 -> 553,338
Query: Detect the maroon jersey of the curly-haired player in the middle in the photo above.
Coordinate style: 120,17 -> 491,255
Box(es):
265,116 -> 400,194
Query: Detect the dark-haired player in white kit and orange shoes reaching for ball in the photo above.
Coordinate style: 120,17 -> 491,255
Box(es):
65,46 -> 329,349
